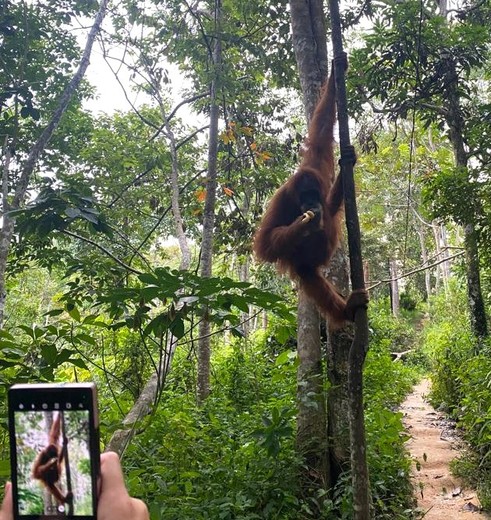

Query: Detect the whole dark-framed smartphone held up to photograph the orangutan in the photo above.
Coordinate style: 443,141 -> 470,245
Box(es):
8,383 -> 100,520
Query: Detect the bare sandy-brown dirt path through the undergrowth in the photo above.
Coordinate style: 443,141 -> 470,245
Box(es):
401,380 -> 491,520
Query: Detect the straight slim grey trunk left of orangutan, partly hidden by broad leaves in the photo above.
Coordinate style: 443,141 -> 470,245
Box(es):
198,0 -> 222,403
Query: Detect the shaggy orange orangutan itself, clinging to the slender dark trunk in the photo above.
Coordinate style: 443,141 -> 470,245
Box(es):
253,68 -> 366,326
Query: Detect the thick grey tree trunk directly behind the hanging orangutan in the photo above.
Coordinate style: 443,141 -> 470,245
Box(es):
290,0 -> 330,493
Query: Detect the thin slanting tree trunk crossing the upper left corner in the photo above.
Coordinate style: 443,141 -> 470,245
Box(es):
0,0 -> 109,327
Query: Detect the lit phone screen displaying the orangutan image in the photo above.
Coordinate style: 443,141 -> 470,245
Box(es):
14,403 -> 94,518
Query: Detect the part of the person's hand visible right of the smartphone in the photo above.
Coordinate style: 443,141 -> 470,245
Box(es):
98,451 -> 150,520
